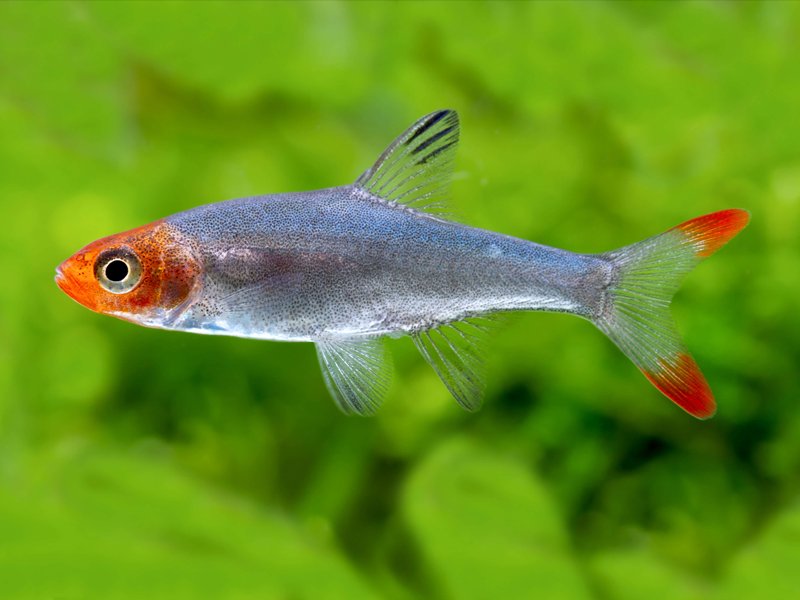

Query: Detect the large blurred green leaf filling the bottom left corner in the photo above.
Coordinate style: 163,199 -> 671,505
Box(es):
0,448 -> 376,600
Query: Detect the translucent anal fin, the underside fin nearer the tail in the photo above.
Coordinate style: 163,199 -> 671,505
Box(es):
412,320 -> 487,411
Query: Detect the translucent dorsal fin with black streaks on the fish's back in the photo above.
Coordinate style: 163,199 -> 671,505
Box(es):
356,110 -> 459,210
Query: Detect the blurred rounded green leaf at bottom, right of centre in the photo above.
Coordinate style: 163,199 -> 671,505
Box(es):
403,438 -> 590,600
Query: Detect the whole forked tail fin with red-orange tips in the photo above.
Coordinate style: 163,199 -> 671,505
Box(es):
594,209 -> 750,419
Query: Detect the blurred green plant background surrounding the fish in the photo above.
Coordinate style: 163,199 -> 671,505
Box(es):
0,2 -> 800,599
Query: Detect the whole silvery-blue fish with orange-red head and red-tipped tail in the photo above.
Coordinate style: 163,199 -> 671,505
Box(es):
55,109 -> 750,419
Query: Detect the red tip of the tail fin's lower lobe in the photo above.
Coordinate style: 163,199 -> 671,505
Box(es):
642,354 -> 717,419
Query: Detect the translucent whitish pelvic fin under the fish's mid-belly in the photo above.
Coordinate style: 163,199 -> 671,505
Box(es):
316,338 -> 392,415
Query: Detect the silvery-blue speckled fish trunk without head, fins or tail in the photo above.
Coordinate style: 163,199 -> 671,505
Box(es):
165,186 -> 614,341
